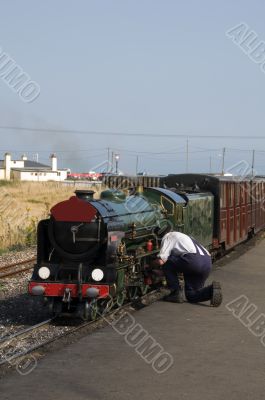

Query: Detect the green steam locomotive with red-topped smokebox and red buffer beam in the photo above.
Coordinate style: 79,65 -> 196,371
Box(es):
29,183 -> 213,319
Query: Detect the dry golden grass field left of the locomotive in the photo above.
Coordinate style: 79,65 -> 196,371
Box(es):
0,181 -> 101,252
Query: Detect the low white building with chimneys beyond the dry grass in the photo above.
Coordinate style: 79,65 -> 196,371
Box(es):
0,153 -> 68,182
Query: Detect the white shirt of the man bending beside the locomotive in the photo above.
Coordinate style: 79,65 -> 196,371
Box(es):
158,232 -> 210,262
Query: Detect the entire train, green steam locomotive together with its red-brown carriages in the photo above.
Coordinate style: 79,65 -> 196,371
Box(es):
29,174 -> 265,320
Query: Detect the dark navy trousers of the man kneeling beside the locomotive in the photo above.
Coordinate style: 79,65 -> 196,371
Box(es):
163,253 -> 212,303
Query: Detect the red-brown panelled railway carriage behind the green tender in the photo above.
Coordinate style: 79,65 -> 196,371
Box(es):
162,174 -> 265,250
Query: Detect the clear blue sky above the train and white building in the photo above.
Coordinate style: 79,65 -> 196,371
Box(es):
0,0 -> 265,173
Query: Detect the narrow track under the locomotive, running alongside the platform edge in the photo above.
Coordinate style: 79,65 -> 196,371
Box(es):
0,290 -> 164,366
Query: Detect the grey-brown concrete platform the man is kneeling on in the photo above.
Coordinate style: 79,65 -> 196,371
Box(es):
0,241 -> 265,400
